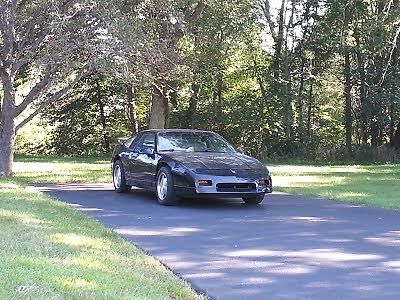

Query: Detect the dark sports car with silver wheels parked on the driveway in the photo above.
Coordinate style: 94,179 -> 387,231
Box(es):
112,130 -> 272,205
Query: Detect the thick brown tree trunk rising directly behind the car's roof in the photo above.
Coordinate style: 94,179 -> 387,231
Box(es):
149,78 -> 168,129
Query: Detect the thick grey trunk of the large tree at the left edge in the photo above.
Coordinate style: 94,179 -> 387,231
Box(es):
0,70 -> 15,176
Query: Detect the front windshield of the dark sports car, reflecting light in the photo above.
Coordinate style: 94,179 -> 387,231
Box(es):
157,132 -> 235,152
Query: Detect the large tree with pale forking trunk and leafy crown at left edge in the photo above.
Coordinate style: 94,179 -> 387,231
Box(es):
0,0 -> 99,176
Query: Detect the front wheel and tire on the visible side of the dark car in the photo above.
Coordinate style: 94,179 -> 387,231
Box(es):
156,167 -> 179,206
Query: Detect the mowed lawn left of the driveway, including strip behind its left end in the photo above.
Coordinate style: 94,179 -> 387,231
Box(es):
0,157 -> 204,299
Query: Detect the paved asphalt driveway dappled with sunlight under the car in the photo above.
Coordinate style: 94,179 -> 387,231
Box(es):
42,185 -> 400,300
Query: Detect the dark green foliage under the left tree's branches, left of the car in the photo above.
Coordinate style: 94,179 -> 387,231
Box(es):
34,75 -> 150,155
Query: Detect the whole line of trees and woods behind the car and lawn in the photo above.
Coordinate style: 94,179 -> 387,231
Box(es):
0,0 -> 400,175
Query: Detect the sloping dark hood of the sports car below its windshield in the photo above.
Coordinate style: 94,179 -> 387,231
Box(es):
162,152 -> 268,172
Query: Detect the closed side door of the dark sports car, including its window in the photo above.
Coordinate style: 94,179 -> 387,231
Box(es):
129,132 -> 157,187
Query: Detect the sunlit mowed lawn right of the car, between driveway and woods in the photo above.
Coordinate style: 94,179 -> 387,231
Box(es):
270,164 -> 400,209
